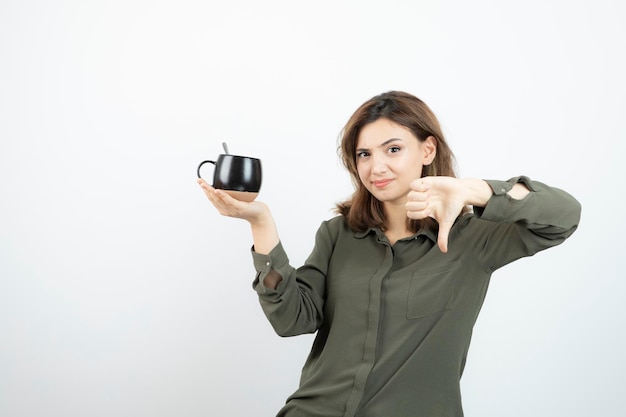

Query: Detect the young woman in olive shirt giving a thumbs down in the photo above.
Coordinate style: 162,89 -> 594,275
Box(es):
199,91 -> 580,417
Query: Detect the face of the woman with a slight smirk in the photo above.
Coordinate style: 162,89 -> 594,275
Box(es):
356,119 -> 436,204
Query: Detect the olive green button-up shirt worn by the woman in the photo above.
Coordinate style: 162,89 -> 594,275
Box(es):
252,177 -> 580,417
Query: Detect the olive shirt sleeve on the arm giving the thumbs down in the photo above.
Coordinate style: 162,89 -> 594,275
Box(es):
473,176 -> 581,271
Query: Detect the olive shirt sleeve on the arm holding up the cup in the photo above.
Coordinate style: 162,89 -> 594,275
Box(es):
252,222 -> 333,336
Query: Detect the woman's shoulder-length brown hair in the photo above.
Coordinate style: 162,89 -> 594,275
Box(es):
336,91 -> 465,232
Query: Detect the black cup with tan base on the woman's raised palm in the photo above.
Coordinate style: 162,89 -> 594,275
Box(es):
198,154 -> 262,201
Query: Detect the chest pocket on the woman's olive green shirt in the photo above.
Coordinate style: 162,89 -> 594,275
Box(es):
406,263 -> 459,319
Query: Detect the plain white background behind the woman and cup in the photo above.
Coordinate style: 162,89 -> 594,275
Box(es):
0,0 -> 626,417
